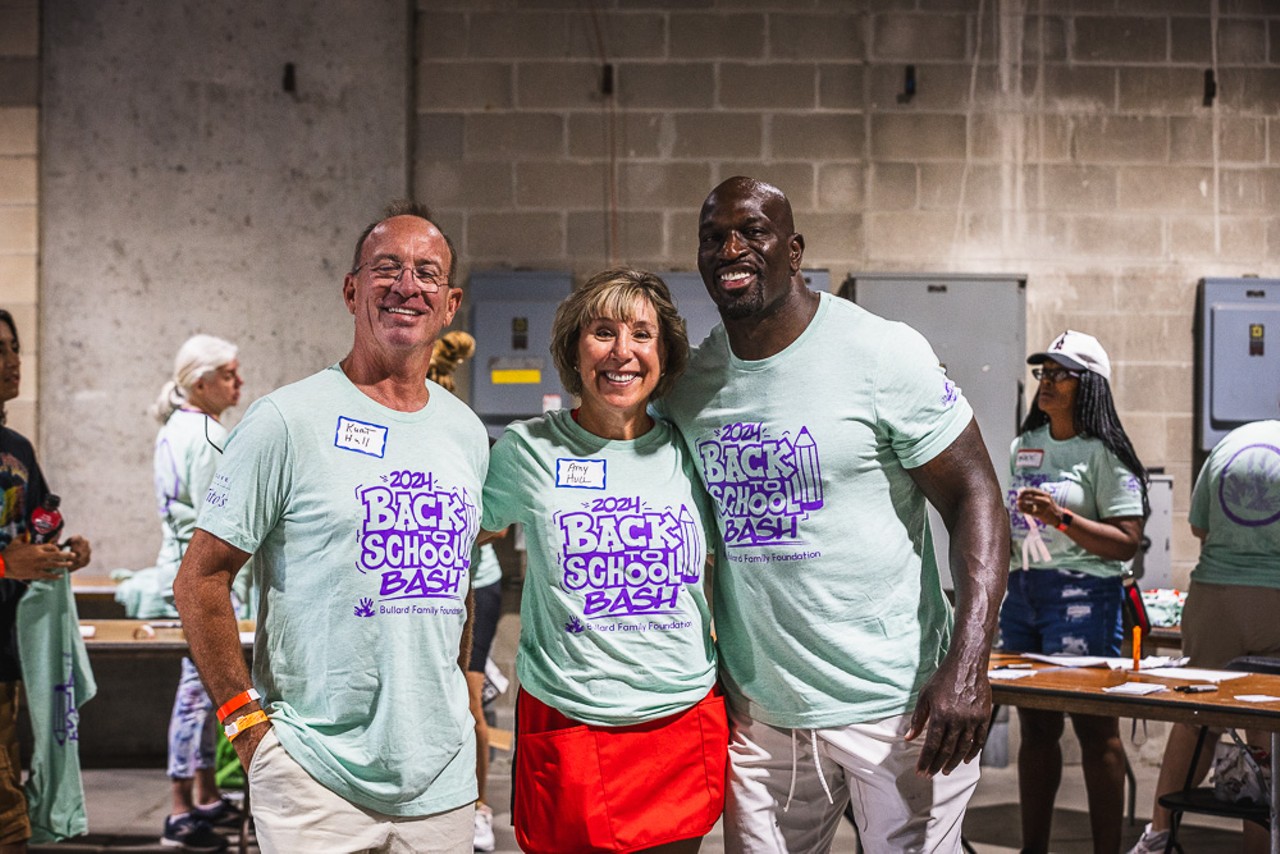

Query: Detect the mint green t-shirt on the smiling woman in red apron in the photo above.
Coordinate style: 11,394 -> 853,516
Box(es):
483,410 -> 716,726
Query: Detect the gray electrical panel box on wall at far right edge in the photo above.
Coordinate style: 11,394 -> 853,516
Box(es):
1196,279 -> 1280,452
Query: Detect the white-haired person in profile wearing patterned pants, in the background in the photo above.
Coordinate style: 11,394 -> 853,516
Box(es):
147,335 -> 244,851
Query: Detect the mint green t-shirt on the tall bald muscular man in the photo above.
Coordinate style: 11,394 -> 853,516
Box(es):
659,293 -> 973,729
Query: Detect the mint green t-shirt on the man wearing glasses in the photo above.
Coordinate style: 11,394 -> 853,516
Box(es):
198,365 -> 489,816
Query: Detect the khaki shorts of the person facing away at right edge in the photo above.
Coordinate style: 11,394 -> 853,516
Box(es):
1183,581 -> 1280,667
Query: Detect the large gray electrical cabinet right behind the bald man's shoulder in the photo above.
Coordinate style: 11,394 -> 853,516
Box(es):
840,273 -> 1029,589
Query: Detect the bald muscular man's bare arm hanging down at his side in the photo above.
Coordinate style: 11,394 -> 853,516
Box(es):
908,421 -> 1009,776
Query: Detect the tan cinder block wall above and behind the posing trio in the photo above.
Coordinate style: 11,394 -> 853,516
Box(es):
413,0 -> 1280,580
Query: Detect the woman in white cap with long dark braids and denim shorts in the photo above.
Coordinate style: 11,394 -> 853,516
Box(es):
1000,329 -> 1147,854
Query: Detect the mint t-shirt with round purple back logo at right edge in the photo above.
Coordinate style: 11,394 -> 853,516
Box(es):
1190,421 -> 1280,588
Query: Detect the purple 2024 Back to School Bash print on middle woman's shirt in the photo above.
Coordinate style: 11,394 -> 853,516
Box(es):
556,497 -> 705,622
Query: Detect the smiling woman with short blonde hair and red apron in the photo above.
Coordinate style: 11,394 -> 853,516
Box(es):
481,269 -> 728,854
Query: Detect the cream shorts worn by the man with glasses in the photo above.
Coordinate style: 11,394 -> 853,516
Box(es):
248,731 -> 475,854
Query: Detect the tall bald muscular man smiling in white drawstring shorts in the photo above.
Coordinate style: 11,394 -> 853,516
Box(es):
657,177 -> 1009,851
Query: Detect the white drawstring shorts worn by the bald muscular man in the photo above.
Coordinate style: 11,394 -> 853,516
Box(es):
724,712 -> 978,854
